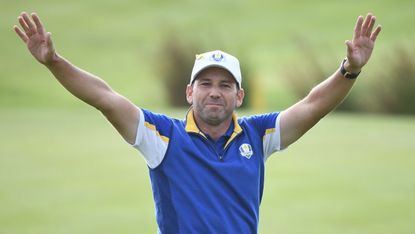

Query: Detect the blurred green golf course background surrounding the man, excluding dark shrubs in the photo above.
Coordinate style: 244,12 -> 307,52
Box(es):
0,0 -> 415,234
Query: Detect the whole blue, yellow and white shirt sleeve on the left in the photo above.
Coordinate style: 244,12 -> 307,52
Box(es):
132,108 -> 172,169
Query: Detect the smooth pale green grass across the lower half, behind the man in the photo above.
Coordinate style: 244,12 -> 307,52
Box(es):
0,107 -> 415,234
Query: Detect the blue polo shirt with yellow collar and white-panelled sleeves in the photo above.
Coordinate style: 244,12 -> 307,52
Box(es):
133,109 -> 280,234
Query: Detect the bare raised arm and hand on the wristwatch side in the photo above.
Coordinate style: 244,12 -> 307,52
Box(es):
280,13 -> 381,147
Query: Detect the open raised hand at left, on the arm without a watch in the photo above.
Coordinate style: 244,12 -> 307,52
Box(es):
13,12 -> 56,65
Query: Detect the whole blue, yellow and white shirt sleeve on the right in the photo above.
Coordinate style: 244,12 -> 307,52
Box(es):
244,112 -> 281,161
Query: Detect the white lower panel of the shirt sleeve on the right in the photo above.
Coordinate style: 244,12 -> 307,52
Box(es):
263,113 -> 281,161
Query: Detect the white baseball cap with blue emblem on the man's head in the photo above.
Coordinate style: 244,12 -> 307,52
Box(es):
190,50 -> 242,88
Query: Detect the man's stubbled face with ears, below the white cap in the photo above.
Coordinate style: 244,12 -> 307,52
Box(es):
186,67 -> 244,126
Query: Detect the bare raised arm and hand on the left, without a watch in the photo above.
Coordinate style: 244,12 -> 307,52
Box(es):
14,12 -> 139,144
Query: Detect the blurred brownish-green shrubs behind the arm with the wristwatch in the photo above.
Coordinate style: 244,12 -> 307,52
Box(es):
284,40 -> 415,114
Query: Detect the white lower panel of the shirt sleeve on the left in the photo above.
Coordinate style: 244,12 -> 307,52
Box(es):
132,109 -> 168,169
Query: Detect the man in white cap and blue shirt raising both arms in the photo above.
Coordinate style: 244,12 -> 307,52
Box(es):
14,13 -> 381,233
